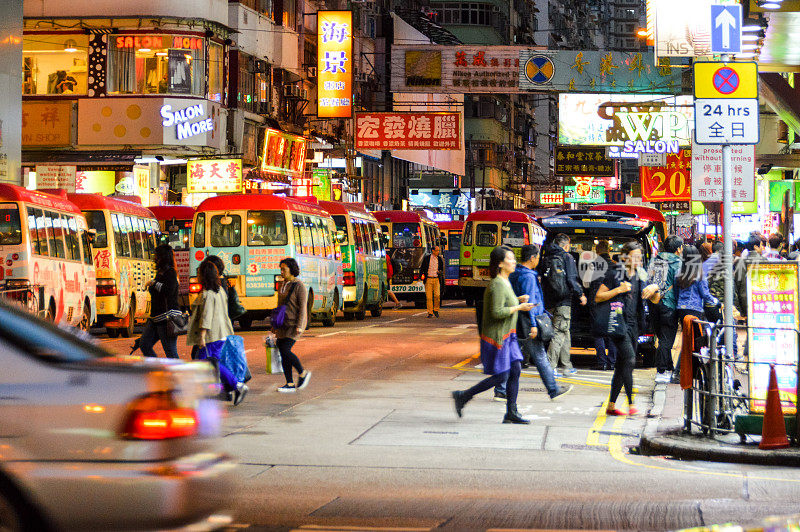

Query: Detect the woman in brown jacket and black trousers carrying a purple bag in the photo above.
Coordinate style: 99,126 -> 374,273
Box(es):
272,257 -> 311,393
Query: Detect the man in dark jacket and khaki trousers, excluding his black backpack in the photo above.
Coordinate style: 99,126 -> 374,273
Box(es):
543,233 -> 586,375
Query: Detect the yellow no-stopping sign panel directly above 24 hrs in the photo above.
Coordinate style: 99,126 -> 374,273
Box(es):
694,62 -> 758,98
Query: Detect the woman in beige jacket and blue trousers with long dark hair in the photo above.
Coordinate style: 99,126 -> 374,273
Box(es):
187,260 -> 249,405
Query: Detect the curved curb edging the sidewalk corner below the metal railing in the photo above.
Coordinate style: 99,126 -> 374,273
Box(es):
638,383 -> 800,467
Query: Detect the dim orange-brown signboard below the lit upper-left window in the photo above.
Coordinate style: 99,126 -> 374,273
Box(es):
22,102 -> 72,147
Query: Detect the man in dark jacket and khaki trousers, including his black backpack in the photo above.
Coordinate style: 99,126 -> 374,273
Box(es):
542,233 -> 586,375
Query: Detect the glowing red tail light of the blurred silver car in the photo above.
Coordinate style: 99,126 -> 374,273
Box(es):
122,392 -> 202,440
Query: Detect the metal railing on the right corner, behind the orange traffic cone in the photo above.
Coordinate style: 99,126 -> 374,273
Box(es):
681,320 -> 800,443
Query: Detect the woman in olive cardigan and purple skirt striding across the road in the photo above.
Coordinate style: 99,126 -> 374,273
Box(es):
453,246 -> 533,424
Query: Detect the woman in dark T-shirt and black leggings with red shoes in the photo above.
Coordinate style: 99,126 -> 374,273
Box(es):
594,241 -> 664,416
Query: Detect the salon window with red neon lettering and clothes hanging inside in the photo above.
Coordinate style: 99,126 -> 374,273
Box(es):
108,34 -> 206,96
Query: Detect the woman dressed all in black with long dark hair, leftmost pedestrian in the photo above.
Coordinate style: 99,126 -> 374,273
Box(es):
139,244 -> 181,358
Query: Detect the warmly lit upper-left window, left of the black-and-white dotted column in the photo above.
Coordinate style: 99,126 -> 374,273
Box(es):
22,34 -> 89,94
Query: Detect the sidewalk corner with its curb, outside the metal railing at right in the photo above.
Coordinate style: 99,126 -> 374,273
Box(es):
639,384 -> 800,467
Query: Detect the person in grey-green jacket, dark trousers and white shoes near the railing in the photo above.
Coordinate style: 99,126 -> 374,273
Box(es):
648,235 -> 683,383
